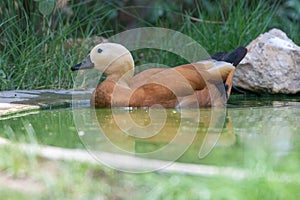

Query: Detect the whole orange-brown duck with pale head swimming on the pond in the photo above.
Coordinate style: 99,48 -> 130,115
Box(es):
71,42 -> 247,108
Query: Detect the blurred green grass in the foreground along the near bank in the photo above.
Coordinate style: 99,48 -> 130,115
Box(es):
0,146 -> 300,200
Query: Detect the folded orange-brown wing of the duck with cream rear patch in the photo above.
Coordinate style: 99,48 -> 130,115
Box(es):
130,61 -> 235,107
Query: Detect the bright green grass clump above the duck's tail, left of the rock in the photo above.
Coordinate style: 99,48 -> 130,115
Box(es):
178,1 -> 277,54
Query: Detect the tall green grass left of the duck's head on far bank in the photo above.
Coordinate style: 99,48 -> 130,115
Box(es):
0,0 -> 113,90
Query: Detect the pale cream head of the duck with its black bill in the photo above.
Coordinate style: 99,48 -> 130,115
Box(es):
71,43 -> 134,79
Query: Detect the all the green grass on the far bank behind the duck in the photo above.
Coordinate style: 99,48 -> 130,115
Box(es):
0,0 -> 299,90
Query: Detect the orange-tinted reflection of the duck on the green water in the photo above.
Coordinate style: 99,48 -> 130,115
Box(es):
88,108 -> 236,159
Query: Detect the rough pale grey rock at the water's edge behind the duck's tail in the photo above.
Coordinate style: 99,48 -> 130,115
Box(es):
233,29 -> 300,94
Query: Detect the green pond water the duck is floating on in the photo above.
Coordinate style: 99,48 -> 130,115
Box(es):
0,96 -> 300,177
